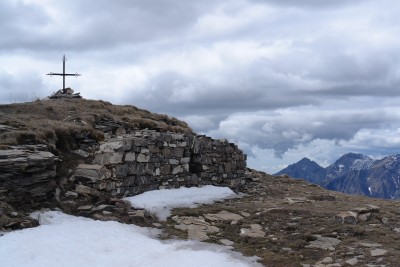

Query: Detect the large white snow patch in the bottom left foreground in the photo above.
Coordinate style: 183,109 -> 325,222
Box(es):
0,211 -> 261,267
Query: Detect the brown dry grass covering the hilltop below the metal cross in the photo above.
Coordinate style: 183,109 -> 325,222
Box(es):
0,99 -> 192,151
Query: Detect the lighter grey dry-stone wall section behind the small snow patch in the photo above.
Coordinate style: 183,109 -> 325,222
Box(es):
75,130 -> 246,196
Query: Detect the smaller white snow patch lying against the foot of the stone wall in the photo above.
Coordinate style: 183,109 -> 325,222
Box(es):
125,185 -> 237,220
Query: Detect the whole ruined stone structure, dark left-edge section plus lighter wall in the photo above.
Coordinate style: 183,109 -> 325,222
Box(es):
0,130 -> 246,208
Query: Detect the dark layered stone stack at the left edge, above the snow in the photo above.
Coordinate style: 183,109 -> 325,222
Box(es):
0,145 -> 57,208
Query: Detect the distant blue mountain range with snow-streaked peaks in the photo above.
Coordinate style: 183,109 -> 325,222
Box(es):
275,153 -> 400,199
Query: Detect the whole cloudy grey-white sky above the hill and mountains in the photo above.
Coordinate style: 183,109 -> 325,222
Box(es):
0,0 -> 400,173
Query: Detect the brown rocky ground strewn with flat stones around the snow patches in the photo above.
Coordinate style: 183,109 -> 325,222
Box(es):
0,172 -> 400,267
